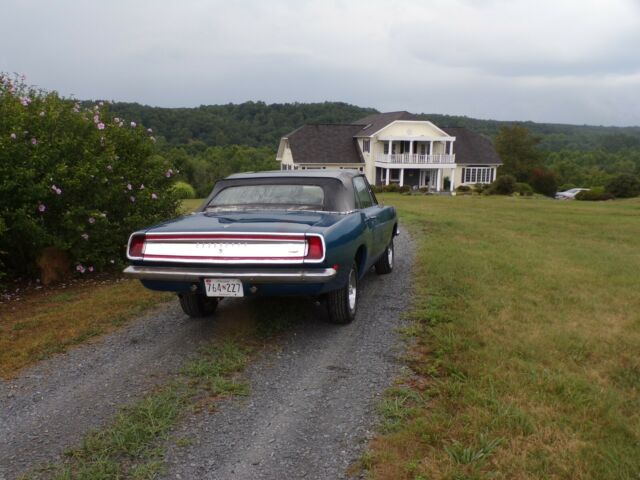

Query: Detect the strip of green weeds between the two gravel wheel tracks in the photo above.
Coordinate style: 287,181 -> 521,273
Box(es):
34,339 -> 252,480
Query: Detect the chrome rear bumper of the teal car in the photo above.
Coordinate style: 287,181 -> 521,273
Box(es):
124,265 -> 338,284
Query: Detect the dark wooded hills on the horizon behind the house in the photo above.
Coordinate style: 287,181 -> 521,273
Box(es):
100,102 -> 640,152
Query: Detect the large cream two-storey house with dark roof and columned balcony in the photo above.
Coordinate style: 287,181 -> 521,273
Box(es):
276,112 -> 502,192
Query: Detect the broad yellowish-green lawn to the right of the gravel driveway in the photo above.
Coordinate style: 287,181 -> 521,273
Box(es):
362,195 -> 640,480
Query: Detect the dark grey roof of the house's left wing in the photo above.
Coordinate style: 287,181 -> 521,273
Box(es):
287,124 -> 364,163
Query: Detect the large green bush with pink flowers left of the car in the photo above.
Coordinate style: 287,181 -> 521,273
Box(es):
0,74 -> 178,276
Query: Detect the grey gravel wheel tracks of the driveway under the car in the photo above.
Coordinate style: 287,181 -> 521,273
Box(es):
0,233 -> 414,480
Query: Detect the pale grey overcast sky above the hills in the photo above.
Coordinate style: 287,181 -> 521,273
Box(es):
0,0 -> 640,125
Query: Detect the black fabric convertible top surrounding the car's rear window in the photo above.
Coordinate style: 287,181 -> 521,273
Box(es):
202,170 -> 362,212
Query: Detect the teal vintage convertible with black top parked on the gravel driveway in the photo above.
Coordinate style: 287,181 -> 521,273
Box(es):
124,170 -> 398,323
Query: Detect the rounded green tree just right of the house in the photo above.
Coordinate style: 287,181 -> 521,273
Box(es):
495,125 -> 543,183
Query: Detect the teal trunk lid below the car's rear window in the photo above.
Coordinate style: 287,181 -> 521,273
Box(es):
147,211 -> 344,233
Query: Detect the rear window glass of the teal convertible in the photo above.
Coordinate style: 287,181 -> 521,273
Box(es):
209,184 -> 324,210
